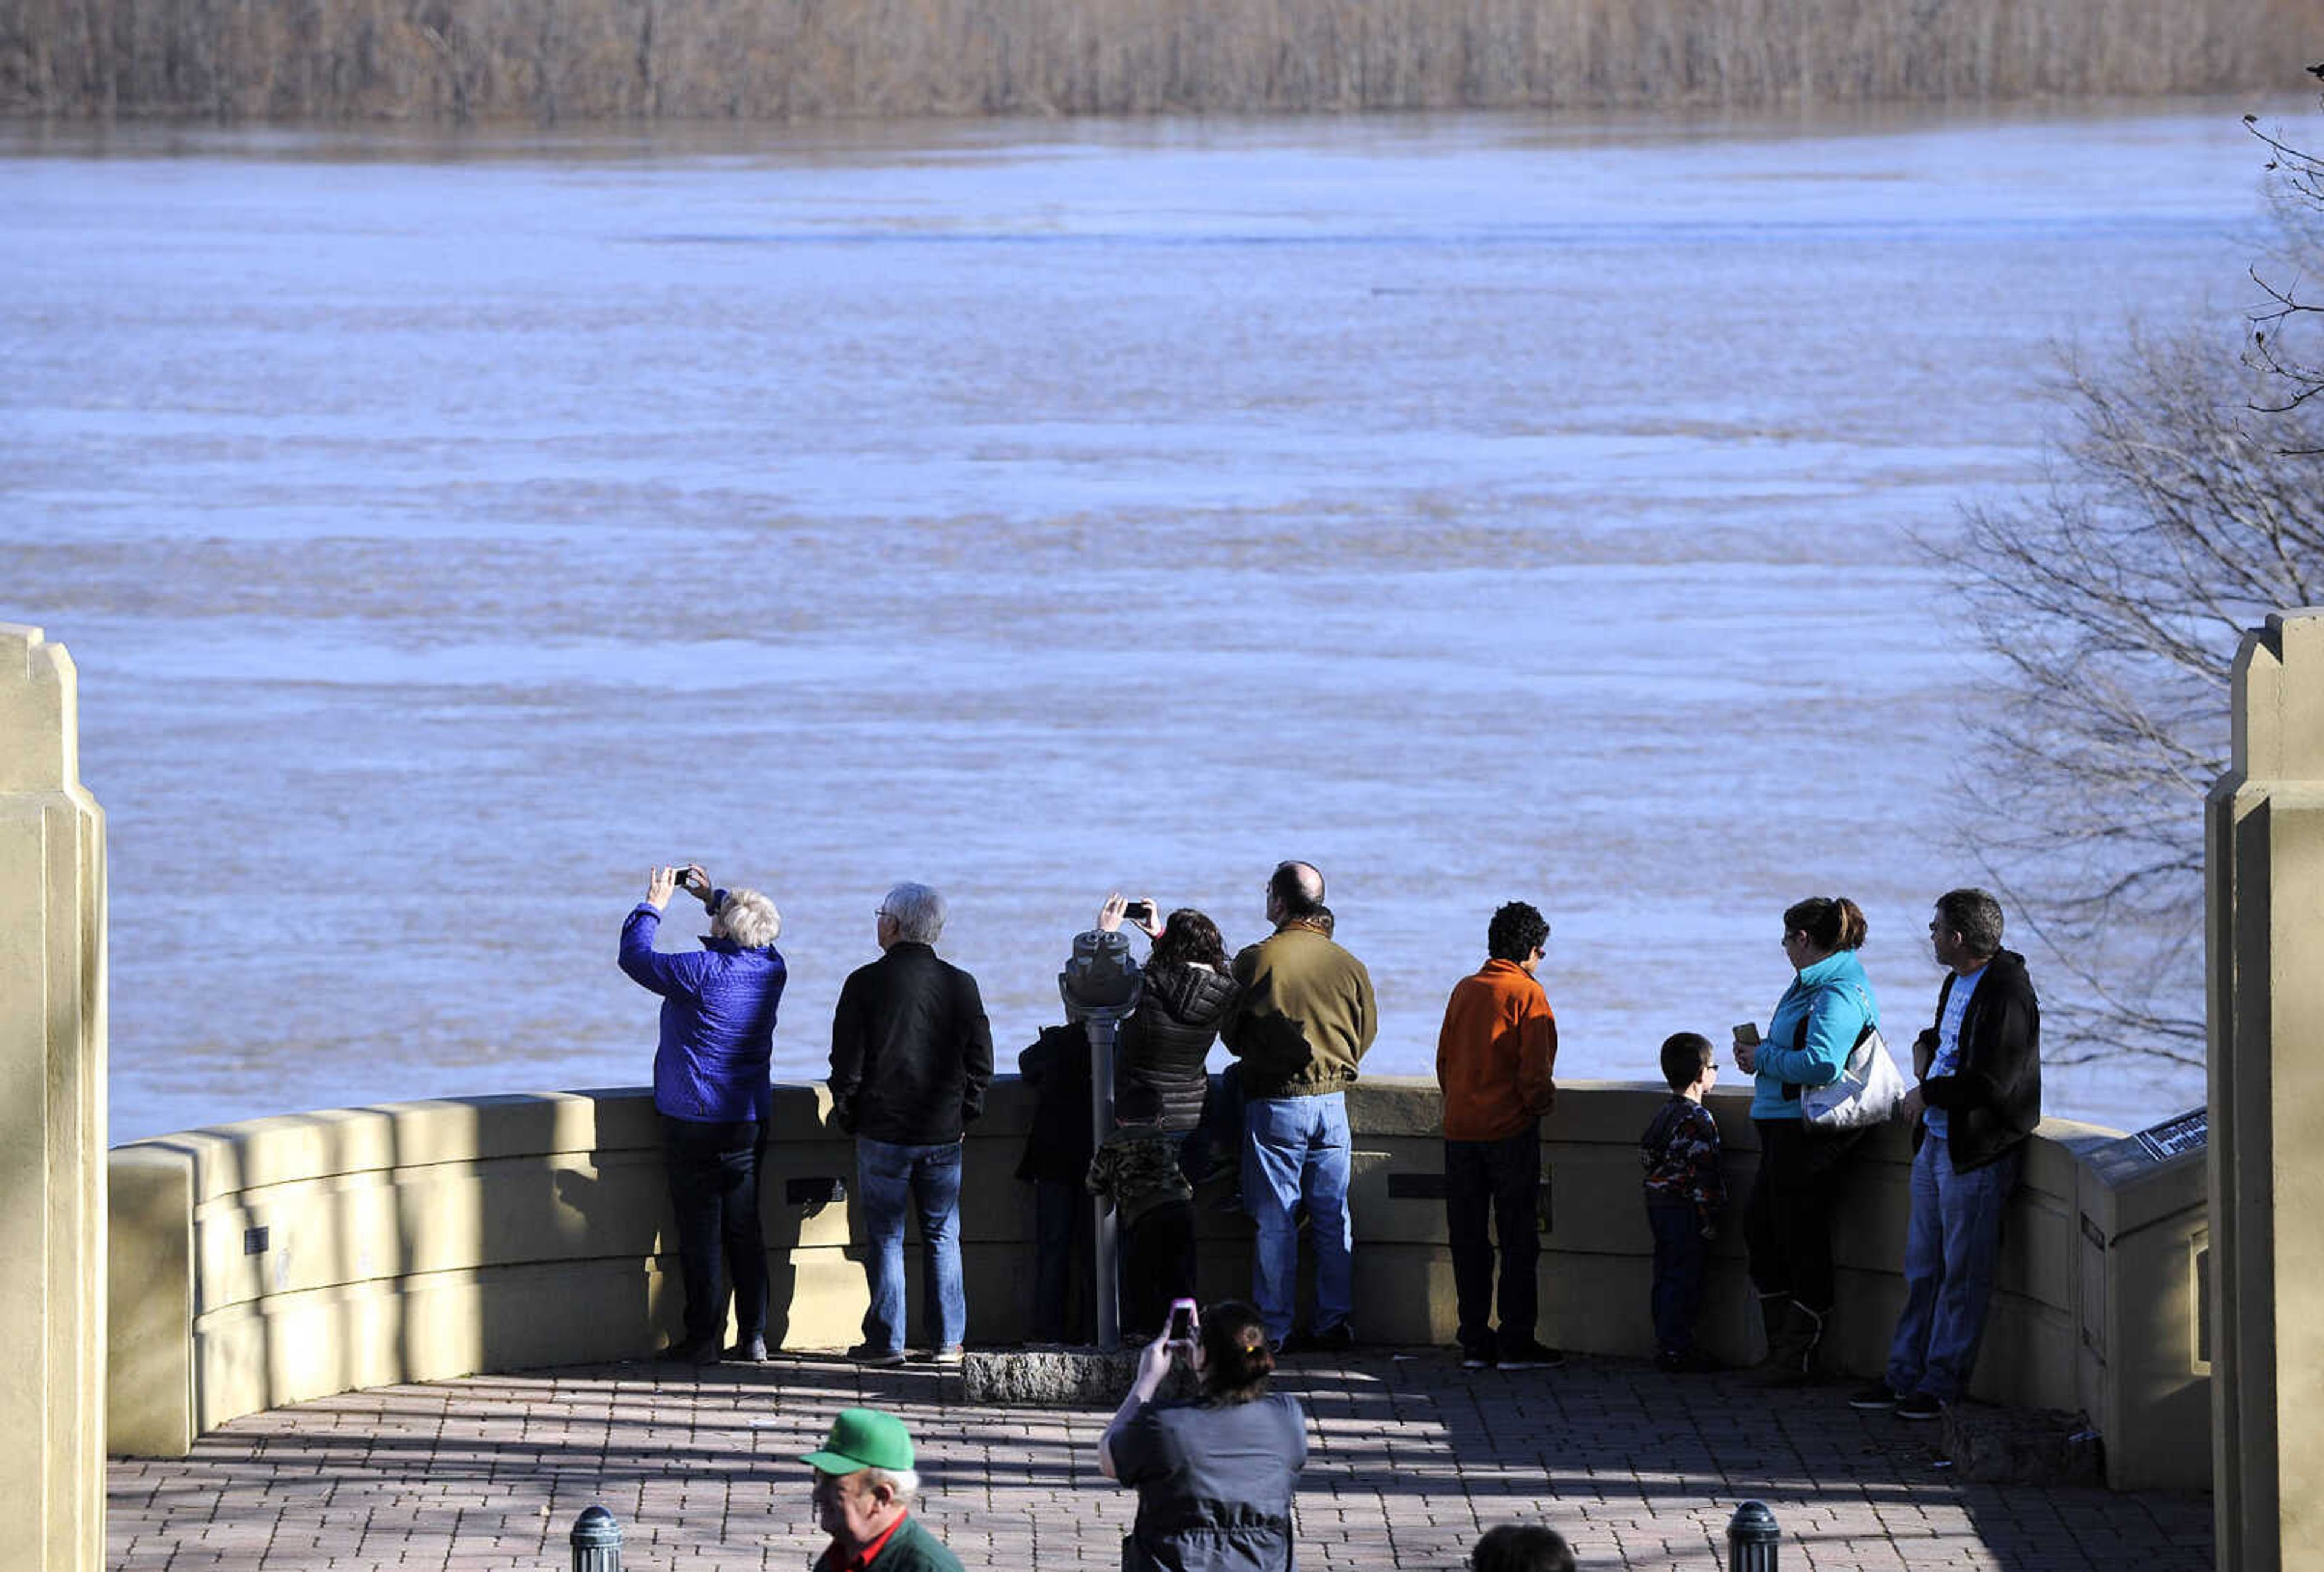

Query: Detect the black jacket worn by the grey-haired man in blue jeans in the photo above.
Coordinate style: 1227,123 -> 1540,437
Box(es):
832,942 -> 993,1146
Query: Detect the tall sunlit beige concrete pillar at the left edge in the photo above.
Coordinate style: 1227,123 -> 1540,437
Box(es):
0,623 -> 105,1572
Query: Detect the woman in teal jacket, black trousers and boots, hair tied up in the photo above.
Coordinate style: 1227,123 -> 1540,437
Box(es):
1736,898 -> 1880,1386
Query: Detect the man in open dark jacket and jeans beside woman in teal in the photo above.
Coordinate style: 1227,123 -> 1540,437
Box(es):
1850,890 -> 2041,1418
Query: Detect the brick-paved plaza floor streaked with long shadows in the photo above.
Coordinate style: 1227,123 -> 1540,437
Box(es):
107,1351 -> 2210,1572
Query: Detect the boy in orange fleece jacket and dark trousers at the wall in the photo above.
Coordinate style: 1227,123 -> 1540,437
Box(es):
1436,900 -> 1566,1370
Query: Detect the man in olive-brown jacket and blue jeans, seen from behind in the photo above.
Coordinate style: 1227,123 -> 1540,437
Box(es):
1220,863 -> 1380,1353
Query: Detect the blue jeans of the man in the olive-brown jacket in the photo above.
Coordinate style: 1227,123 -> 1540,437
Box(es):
1243,1091 -> 1355,1342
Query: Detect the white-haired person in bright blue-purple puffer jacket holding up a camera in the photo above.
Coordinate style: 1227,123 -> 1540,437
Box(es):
620,863 -> 783,1365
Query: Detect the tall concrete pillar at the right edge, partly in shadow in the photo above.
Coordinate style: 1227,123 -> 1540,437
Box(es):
2205,607 -> 2324,1572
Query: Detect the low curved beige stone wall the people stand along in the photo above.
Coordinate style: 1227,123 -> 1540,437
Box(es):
109,1079 -> 2210,1486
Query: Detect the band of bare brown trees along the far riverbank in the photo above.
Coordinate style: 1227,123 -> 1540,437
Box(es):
0,0 -> 2303,125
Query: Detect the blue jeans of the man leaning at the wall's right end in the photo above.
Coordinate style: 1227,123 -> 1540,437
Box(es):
1887,1135 -> 2024,1403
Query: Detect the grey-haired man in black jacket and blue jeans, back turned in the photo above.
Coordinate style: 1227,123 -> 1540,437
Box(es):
830,884 -> 993,1365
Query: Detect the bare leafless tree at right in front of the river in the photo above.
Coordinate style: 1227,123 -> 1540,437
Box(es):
1934,98 -> 2324,1065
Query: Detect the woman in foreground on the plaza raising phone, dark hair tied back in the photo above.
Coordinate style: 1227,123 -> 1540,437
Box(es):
1097,1300 -> 1306,1572
